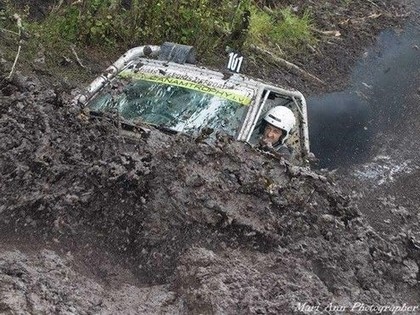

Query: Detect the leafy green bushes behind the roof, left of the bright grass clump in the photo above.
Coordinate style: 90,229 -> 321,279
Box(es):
23,0 -> 244,50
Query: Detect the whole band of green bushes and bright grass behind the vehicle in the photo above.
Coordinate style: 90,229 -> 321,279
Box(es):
0,0 -> 313,63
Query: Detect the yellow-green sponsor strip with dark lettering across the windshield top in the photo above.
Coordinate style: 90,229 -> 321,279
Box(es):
119,70 -> 251,105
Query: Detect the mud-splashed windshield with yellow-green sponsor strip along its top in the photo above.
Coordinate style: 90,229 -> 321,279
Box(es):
88,72 -> 251,136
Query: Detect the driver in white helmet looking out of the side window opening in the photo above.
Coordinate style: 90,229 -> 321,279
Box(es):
260,106 -> 296,160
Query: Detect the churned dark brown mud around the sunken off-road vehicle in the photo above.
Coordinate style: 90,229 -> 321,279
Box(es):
0,1 -> 420,314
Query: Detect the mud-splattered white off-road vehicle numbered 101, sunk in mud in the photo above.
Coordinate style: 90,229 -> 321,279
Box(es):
75,43 -> 309,164
